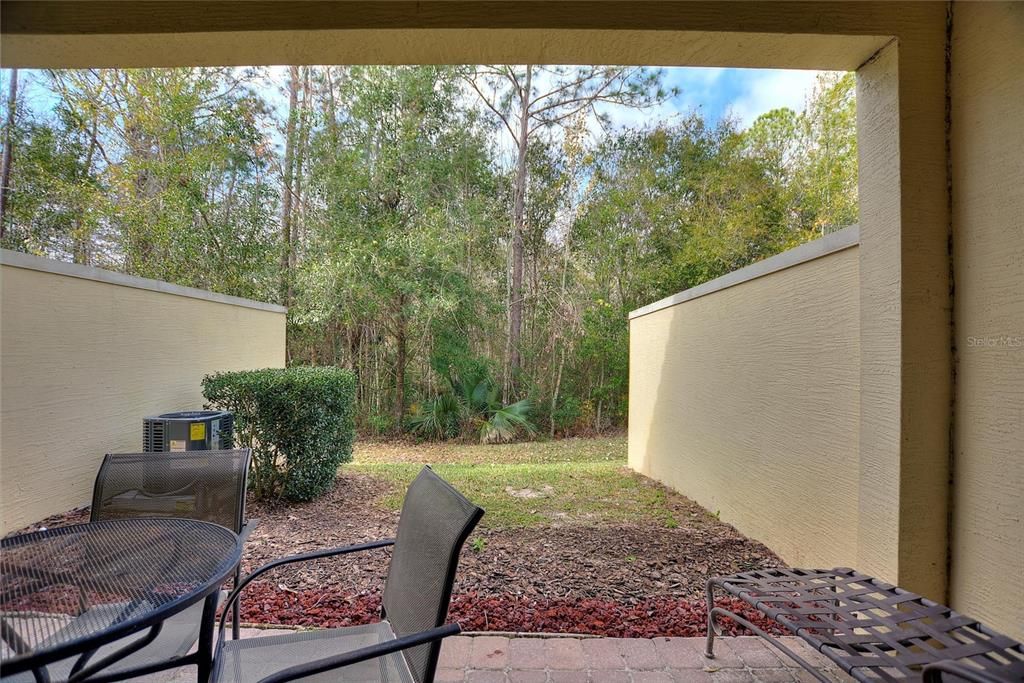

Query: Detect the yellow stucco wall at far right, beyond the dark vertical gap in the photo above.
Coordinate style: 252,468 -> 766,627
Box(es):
950,2 -> 1024,639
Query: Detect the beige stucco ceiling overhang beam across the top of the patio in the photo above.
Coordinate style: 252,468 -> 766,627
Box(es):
0,0 -> 897,70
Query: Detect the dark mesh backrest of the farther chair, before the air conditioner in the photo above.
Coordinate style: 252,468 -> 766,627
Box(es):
90,449 -> 251,533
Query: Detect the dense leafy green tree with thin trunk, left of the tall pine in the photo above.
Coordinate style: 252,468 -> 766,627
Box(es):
294,67 -> 501,428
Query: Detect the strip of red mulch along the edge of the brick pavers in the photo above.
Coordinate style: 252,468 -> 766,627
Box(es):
242,583 -> 784,638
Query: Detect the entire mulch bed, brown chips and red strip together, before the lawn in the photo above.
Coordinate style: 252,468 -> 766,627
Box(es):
12,471 -> 782,637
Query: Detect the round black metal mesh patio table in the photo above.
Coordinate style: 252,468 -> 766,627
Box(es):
0,518 -> 242,681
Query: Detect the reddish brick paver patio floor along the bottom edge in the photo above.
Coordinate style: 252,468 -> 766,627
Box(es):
135,629 -> 852,683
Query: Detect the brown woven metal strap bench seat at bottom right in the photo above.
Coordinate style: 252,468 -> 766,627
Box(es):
706,568 -> 1024,683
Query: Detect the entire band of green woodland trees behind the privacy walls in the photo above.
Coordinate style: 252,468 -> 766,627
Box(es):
6,66 -> 857,440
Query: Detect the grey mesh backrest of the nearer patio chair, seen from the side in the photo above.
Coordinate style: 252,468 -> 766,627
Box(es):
383,467 -> 483,683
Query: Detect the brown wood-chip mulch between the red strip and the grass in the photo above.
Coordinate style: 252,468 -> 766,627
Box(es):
244,472 -> 782,605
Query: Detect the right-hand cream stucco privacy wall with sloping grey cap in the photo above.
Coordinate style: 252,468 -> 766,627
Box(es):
629,226 -> 860,566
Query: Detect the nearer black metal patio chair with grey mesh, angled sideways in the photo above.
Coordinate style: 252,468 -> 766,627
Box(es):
213,467 -> 483,683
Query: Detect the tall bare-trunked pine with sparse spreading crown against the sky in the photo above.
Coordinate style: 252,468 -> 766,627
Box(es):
463,65 -> 667,400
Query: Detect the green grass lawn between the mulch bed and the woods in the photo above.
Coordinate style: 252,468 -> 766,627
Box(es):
354,436 -> 707,528
